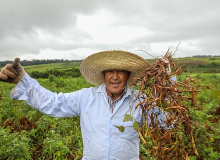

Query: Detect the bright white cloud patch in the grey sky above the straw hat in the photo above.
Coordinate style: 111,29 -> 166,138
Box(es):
77,10 -> 152,44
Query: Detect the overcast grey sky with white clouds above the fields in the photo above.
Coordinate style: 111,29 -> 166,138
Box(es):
0,0 -> 220,61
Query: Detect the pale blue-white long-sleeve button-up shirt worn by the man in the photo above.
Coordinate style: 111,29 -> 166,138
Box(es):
9,73 -> 175,160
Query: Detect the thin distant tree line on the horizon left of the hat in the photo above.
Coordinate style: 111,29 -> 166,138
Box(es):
0,59 -> 82,66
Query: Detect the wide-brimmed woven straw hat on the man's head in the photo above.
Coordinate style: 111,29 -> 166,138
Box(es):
80,50 -> 150,86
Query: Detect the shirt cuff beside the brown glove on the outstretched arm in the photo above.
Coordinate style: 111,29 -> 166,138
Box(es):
9,72 -> 32,99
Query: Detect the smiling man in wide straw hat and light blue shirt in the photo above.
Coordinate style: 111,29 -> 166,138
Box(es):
0,50 -> 172,160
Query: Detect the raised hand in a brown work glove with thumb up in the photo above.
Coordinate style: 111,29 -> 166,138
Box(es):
0,58 -> 25,84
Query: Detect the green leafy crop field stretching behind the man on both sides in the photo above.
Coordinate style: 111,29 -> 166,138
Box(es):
0,57 -> 220,160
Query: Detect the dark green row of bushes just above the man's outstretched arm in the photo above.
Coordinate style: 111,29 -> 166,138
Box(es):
29,68 -> 81,78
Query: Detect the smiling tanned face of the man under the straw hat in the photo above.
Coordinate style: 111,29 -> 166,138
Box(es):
104,69 -> 129,97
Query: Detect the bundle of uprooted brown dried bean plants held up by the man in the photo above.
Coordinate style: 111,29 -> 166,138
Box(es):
134,48 -> 199,160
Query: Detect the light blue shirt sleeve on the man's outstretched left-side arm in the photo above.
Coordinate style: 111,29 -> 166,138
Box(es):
9,73 -> 86,117
